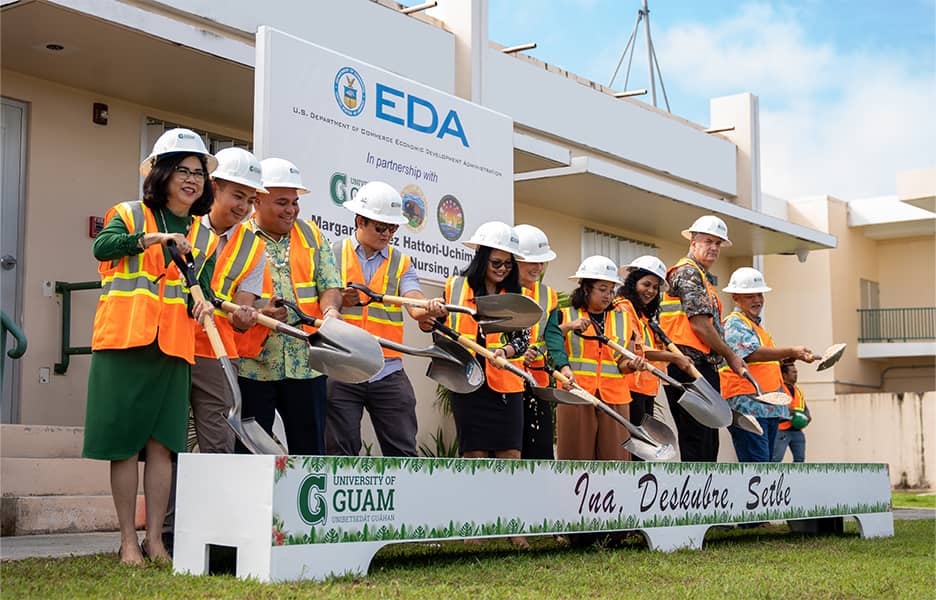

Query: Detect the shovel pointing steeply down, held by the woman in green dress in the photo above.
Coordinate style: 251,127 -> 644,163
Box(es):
166,241 -> 286,455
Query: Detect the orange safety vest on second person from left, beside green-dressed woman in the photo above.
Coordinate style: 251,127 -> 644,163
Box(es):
195,223 -> 270,358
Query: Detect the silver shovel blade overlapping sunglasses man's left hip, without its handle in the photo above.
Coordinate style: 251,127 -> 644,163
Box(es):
308,319 -> 384,383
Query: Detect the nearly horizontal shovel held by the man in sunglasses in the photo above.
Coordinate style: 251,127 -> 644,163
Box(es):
348,283 -> 543,333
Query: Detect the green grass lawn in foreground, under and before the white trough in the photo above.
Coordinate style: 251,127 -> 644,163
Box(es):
0,520 -> 936,600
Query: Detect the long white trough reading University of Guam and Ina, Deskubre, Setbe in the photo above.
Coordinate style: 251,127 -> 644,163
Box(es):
174,454 -> 893,581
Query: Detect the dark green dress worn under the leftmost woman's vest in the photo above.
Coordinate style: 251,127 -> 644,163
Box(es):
82,209 -> 214,460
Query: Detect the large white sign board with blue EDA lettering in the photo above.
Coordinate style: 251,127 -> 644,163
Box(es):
254,27 -> 513,282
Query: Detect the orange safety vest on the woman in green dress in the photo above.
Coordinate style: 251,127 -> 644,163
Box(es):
91,201 -> 218,364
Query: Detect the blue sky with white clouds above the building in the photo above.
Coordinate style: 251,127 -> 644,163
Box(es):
489,0 -> 936,200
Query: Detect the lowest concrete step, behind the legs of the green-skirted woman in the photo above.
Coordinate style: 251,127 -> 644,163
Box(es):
0,494 -> 146,536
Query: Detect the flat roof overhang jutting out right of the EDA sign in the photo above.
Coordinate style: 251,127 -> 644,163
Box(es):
514,156 -> 837,256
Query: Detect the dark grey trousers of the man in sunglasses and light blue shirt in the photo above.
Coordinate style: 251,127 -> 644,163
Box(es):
325,369 -> 417,456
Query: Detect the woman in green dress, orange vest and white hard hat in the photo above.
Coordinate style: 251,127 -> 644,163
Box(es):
83,129 -> 217,564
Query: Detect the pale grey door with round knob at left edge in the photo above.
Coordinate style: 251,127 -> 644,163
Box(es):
0,98 -> 29,423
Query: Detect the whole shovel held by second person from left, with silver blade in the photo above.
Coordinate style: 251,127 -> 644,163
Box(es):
212,299 -> 383,383
